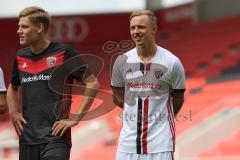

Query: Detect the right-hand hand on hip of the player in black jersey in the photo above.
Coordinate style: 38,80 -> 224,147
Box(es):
52,118 -> 79,136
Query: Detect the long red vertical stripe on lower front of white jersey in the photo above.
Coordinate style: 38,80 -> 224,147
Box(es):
142,97 -> 149,154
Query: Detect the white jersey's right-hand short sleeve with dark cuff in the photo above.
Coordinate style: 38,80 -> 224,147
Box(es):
170,60 -> 186,91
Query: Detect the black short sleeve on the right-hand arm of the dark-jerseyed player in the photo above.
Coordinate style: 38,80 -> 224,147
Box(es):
66,46 -> 92,80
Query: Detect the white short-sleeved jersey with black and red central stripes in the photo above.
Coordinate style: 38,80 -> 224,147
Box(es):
111,46 -> 185,154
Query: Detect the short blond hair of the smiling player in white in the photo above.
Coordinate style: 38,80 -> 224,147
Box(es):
129,10 -> 157,27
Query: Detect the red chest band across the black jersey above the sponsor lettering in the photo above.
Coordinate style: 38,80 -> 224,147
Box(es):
17,51 -> 65,74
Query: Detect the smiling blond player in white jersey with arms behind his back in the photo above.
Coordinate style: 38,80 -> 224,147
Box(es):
111,10 -> 185,160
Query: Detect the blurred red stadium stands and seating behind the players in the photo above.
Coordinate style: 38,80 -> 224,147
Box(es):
0,0 -> 240,160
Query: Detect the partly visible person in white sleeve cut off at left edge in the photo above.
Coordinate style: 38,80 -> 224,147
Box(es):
0,67 -> 7,114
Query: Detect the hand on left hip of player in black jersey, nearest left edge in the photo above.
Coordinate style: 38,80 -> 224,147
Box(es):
10,112 -> 27,136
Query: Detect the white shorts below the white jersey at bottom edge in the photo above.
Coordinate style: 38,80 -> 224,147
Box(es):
116,152 -> 174,160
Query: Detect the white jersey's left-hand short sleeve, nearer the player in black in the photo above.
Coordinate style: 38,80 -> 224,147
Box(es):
111,55 -> 125,87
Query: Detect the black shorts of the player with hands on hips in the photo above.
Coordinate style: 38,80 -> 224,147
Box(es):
19,140 -> 71,160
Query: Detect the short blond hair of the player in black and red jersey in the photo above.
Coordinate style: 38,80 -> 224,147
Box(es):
19,6 -> 51,33
